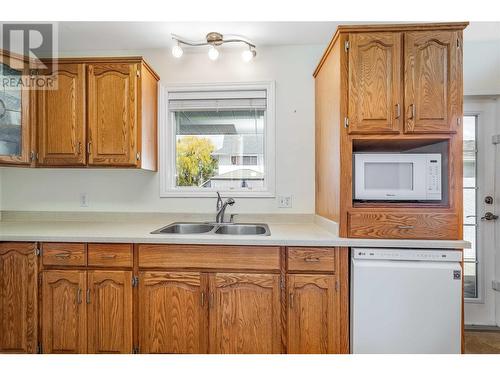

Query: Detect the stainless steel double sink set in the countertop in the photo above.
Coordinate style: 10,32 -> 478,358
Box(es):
151,222 -> 271,236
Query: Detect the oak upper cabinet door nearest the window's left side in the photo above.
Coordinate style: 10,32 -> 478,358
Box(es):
88,63 -> 138,166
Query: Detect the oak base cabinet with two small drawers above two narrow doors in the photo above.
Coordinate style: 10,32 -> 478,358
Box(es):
41,242 -> 133,354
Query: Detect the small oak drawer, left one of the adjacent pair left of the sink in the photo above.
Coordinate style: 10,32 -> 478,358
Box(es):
42,242 -> 87,266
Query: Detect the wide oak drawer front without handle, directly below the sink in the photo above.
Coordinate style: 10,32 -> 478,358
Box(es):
139,245 -> 280,271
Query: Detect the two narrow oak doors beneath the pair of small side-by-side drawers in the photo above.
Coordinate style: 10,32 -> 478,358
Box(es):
42,270 -> 133,354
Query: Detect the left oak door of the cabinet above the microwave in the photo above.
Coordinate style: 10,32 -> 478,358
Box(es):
347,33 -> 403,133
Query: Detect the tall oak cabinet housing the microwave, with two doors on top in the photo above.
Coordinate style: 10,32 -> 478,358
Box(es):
313,22 -> 468,240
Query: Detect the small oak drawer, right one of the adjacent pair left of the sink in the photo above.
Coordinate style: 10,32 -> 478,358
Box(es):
88,243 -> 133,267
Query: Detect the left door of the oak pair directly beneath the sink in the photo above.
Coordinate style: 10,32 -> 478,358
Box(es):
139,272 -> 208,354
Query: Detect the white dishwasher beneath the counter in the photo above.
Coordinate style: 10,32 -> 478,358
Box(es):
351,248 -> 462,354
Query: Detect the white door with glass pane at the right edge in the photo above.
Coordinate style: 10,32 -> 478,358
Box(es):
463,99 -> 500,326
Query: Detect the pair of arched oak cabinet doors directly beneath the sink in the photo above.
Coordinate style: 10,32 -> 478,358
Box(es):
139,271 -> 281,354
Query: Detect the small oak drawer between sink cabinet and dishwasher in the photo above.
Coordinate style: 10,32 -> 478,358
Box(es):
287,247 -> 335,272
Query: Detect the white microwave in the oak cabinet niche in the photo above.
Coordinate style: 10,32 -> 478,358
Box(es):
354,153 -> 442,201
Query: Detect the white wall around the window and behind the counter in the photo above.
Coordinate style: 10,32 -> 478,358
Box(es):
1,46 -> 325,213
